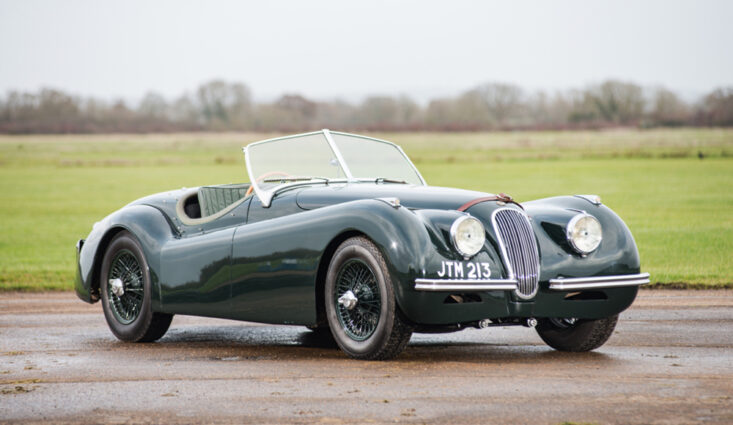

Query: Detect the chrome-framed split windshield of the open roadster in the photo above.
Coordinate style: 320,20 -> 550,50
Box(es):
245,130 -> 425,205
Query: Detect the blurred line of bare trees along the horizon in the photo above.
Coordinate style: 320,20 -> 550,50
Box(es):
0,80 -> 733,134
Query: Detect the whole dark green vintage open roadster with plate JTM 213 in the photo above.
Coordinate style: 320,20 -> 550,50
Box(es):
76,130 -> 649,359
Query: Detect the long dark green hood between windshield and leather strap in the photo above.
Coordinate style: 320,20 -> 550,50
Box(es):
297,183 -> 491,210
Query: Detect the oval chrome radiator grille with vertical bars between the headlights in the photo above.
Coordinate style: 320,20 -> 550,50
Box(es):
492,208 -> 540,298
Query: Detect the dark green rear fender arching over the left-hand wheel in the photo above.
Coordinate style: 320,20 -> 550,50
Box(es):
74,205 -> 176,310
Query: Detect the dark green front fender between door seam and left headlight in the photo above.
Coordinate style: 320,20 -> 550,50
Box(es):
226,199 -> 430,325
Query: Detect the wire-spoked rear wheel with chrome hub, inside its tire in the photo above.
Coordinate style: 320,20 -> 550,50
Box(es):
105,249 -> 144,325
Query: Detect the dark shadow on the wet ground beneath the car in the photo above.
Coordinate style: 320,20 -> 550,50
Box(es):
97,325 -> 616,365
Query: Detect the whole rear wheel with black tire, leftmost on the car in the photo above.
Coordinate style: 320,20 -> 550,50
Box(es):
99,231 -> 173,342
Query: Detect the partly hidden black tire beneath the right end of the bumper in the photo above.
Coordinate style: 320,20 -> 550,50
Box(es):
537,315 -> 618,352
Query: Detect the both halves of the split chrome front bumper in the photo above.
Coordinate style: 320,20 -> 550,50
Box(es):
415,273 -> 649,292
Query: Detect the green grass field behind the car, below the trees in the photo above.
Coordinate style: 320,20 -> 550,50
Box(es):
0,129 -> 733,290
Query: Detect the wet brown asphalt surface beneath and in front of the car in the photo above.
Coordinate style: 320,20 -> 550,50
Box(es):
0,290 -> 733,424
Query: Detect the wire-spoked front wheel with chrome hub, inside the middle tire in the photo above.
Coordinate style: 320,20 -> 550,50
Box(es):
333,258 -> 382,341
